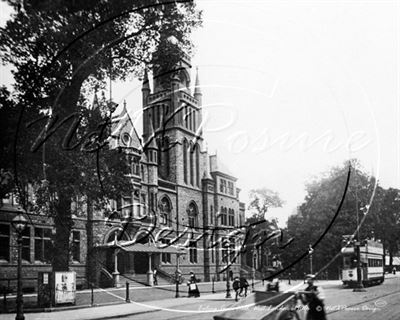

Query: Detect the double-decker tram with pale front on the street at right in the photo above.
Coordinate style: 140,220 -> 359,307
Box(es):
341,240 -> 385,286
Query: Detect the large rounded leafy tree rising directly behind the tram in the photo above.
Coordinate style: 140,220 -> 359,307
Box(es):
283,160 -> 384,276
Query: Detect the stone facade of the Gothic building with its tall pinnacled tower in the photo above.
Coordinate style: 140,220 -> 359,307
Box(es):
0,58 -> 244,292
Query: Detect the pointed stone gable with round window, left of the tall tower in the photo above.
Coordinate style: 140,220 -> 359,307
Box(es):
110,102 -> 142,153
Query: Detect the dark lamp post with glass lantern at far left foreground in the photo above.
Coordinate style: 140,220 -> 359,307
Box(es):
12,208 -> 27,320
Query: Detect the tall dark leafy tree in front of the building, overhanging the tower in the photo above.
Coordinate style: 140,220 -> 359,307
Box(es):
0,0 -> 200,270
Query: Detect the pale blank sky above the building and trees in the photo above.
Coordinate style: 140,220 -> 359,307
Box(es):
0,0 -> 400,226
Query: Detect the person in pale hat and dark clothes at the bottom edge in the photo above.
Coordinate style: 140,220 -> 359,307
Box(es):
300,275 -> 326,320
